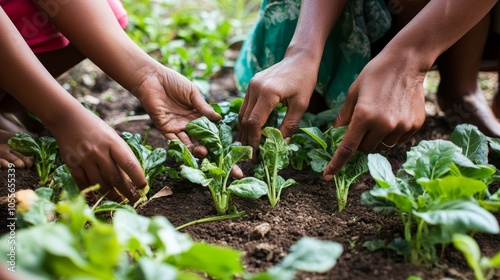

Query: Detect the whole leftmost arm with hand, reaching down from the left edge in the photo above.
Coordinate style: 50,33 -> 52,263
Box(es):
0,8 -> 146,201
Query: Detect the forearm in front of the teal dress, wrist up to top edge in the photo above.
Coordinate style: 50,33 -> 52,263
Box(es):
287,0 -> 347,63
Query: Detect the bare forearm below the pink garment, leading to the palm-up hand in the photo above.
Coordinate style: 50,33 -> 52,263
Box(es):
33,0 -> 157,92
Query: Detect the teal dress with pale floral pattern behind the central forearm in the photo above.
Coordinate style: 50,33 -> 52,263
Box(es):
234,0 -> 391,114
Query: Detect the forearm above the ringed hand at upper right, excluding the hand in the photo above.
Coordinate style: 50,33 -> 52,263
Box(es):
381,0 -> 497,72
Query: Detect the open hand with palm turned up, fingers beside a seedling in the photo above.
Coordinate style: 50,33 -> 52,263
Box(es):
134,66 -> 221,157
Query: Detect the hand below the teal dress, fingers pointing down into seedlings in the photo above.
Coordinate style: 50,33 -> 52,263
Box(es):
238,55 -> 318,162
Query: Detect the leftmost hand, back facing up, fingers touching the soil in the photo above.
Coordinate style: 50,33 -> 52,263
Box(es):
48,107 -> 147,203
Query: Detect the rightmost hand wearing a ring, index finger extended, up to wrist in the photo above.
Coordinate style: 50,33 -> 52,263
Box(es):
323,55 -> 426,181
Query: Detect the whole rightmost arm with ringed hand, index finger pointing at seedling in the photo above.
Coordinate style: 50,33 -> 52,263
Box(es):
323,0 -> 497,180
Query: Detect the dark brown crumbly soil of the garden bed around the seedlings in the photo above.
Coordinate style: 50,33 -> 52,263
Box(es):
0,61 -> 500,279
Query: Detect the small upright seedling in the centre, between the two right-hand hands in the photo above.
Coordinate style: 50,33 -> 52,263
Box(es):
254,127 -> 298,206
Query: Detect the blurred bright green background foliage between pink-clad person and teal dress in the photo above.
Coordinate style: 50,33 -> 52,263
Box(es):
123,0 -> 232,94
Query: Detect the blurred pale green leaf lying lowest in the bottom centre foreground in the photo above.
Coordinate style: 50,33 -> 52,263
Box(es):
279,237 -> 343,273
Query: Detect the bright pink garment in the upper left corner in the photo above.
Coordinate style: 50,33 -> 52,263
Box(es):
0,0 -> 128,53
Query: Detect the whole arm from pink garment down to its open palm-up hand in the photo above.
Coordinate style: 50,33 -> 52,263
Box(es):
33,0 -> 220,154
